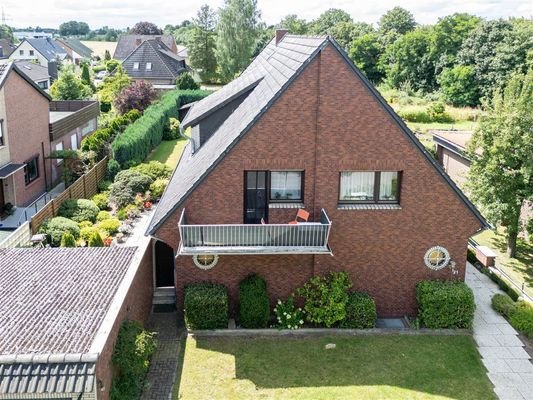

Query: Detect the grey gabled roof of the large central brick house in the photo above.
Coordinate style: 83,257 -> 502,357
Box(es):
147,34 -> 488,234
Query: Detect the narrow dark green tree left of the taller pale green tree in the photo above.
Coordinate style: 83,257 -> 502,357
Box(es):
189,4 -> 217,82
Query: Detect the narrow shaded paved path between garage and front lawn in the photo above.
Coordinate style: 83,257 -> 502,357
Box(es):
141,312 -> 183,400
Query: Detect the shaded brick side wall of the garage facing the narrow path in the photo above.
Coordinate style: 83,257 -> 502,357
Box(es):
96,243 -> 153,400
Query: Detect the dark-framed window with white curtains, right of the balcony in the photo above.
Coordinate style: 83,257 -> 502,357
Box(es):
339,171 -> 401,204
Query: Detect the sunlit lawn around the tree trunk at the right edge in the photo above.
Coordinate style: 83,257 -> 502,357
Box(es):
474,228 -> 533,297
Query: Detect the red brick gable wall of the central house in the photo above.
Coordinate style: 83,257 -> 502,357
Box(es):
156,46 -> 479,316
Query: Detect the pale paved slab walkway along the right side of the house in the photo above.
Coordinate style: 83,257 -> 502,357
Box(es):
466,264 -> 533,400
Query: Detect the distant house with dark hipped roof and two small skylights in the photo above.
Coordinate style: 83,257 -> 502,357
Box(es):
122,39 -> 187,89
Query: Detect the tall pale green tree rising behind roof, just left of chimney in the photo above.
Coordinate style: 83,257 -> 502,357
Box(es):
216,0 -> 261,82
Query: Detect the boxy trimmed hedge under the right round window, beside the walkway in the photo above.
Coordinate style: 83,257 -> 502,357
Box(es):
416,281 -> 476,329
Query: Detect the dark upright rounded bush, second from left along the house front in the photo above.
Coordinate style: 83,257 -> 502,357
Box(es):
239,275 -> 270,328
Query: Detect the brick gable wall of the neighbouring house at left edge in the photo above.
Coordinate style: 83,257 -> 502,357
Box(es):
4,71 -> 50,206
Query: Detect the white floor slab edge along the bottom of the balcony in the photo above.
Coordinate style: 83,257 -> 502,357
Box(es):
178,246 -> 333,256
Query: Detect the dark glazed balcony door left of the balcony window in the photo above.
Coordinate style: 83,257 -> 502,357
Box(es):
244,171 -> 268,224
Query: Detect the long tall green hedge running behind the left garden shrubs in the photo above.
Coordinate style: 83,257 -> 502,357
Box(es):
111,90 -> 211,168
